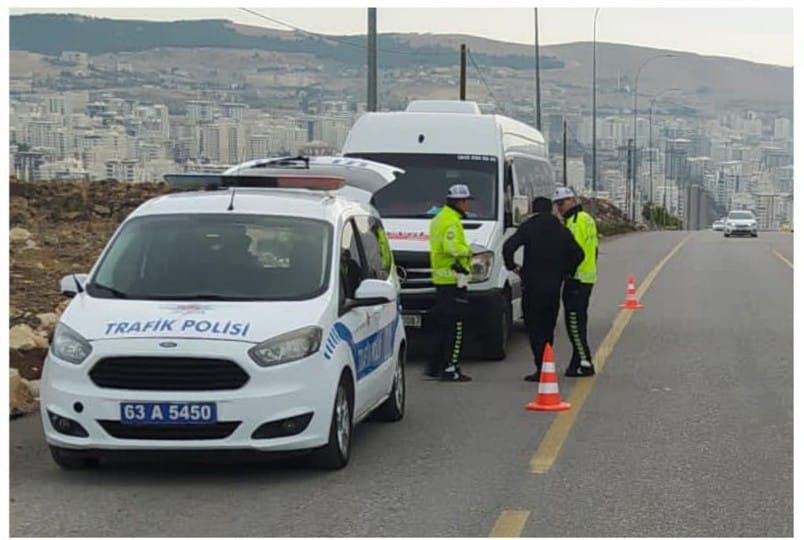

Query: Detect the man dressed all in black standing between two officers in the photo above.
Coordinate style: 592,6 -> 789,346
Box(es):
503,197 -> 584,381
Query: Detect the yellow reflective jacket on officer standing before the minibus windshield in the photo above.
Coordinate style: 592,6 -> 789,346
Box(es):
430,204 -> 472,285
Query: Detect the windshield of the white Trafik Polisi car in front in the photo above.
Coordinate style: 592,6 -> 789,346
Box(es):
87,214 -> 332,301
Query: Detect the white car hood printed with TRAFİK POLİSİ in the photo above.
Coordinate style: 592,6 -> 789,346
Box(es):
61,293 -> 326,343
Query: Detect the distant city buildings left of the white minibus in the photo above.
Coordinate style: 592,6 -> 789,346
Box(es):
10,92 -> 359,182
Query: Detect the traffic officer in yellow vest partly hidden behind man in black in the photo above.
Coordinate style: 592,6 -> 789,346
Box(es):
553,187 -> 598,377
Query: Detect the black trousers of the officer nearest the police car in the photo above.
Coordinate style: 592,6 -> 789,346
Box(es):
427,285 -> 468,376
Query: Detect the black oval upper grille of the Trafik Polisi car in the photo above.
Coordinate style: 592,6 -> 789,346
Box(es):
89,356 -> 249,390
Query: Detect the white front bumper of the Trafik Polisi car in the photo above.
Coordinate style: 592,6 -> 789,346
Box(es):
41,339 -> 337,452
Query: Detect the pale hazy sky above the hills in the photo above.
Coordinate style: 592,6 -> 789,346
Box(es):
11,7 -> 793,66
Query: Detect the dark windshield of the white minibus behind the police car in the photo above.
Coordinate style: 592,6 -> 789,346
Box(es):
349,154 -> 497,220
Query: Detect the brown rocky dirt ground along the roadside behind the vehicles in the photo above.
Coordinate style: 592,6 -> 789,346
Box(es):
9,180 -> 631,402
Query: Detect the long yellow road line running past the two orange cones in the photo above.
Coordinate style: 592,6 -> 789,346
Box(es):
530,235 -> 690,474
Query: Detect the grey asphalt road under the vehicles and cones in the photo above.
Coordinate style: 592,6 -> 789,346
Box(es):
10,231 -> 793,536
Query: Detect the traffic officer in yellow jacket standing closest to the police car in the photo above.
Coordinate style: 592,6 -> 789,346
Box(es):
426,184 -> 473,382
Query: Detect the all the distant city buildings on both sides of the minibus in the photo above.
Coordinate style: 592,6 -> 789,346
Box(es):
10,66 -> 793,229
